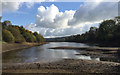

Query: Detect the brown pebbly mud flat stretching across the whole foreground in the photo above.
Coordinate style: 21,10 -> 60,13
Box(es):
3,59 -> 120,74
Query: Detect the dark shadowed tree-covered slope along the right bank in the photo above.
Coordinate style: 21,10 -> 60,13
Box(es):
47,16 -> 120,46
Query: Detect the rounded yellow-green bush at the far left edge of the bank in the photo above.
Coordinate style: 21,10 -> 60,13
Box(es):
2,29 -> 15,42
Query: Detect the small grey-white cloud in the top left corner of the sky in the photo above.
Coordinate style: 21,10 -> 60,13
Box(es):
0,0 -> 55,14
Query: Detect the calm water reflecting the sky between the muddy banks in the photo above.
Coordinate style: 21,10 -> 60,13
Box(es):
3,42 -> 100,63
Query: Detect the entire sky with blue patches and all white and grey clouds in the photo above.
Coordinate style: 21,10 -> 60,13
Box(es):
0,0 -> 118,37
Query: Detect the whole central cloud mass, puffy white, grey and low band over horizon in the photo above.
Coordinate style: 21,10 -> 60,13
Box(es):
26,2 -> 117,37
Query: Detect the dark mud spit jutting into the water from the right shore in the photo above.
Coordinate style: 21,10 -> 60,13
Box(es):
49,46 -> 120,63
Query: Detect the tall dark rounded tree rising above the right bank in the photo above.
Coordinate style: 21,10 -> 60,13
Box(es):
98,20 -> 115,41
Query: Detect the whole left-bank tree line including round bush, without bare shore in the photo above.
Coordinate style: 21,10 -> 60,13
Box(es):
1,21 -> 45,43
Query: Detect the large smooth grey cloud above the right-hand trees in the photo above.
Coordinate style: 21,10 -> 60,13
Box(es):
69,2 -> 118,25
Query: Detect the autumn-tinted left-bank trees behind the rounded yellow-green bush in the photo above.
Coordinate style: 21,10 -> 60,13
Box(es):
1,21 -> 44,43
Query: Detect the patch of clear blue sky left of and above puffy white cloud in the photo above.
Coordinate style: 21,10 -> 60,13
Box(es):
2,2 -> 83,26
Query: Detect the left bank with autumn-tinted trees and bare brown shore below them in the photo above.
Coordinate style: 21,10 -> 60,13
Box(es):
0,21 -> 46,52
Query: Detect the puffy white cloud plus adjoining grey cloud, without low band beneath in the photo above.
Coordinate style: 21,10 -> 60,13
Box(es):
36,2 -> 118,28
